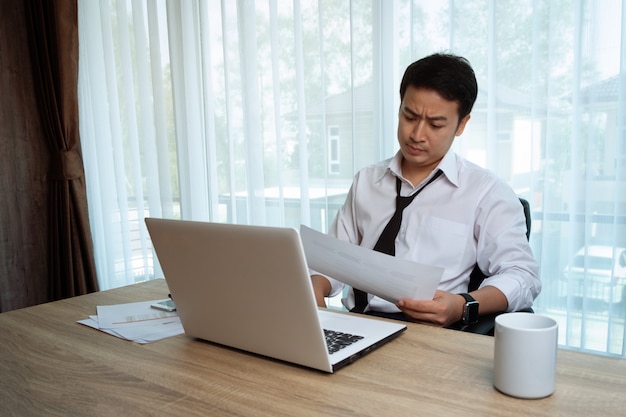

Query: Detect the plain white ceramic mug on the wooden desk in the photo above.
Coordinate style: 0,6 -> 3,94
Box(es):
493,313 -> 558,398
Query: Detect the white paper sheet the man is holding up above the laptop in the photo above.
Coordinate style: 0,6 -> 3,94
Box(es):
300,225 -> 444,304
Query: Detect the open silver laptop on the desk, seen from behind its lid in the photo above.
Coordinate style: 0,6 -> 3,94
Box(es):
146,218 -> 406,373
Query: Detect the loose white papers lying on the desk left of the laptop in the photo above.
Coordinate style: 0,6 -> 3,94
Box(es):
78,300 -> 184,343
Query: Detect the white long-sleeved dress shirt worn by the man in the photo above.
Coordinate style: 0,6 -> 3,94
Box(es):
329,151 -> 541,312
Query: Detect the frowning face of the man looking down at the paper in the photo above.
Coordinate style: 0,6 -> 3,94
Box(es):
398,86 -> 470,181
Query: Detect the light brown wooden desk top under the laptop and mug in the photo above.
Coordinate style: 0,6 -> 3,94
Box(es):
0,280 -> 626,417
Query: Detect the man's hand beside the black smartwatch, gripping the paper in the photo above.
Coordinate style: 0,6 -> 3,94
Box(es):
397,290 -> 465,327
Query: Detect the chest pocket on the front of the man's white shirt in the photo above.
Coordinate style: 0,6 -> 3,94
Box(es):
406,216 -> 476,272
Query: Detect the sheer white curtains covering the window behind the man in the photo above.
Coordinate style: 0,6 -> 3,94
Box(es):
79,0 -> 626,356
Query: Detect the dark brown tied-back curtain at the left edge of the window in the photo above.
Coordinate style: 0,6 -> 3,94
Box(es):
26,0 -> 98,300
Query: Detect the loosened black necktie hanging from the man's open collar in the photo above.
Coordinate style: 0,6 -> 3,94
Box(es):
350,170 -> 443,313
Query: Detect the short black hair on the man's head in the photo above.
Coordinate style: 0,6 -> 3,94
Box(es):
400,53 -> 478,121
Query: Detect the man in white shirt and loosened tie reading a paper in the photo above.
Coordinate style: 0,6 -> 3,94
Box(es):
311,54 -> 541,326
